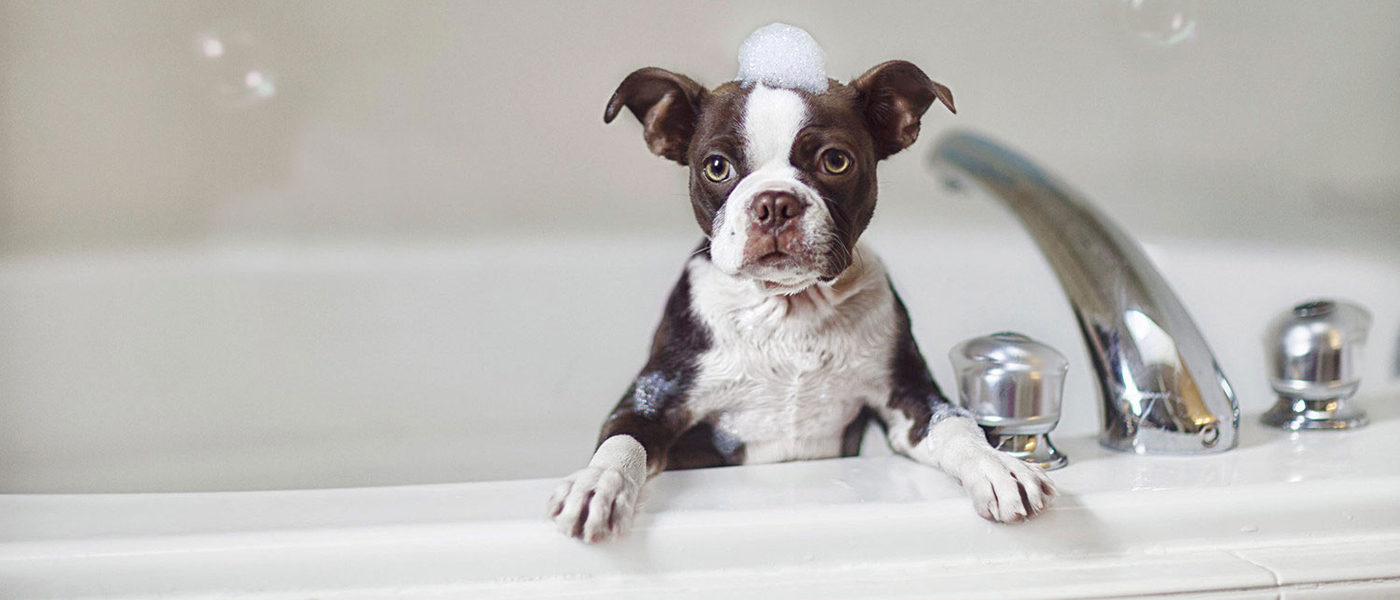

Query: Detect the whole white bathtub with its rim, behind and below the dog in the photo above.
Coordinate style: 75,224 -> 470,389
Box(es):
0,221 -> 1400,599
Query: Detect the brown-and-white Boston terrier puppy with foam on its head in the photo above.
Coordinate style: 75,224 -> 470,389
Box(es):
547,24 -> 1056,543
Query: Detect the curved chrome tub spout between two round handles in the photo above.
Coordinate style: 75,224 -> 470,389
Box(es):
932,131 -> 1239,455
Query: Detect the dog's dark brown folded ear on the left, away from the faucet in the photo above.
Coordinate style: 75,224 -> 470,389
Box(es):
603,67 -> 710,165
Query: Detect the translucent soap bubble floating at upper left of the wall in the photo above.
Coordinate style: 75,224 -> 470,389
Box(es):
195,27 -> 277,109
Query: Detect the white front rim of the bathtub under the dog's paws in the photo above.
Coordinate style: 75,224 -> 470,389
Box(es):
0,413 -> 1400,597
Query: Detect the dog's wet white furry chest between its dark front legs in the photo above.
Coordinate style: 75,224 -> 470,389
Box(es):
689,252 -> 897,464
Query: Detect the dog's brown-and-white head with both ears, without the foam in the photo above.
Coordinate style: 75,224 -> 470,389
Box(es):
603,27 -> 953,292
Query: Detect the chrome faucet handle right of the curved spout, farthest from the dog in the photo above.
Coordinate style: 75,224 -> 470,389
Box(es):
1263,299 -> 1371,431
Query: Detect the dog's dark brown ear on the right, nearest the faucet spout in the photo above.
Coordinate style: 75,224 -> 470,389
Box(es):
851,60 -> 958,159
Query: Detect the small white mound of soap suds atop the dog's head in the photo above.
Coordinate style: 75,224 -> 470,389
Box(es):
735,22 -> 827,94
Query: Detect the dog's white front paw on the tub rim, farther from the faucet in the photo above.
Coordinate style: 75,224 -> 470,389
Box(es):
549,467 -> 641,543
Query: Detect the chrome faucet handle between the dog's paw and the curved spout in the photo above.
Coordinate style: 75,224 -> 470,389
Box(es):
948,331 -> 1070,470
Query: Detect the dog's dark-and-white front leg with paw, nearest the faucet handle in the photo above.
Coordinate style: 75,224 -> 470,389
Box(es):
872,281 -> 1056,523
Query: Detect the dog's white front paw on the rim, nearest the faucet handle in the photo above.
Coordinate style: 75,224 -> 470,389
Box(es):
960,448 -> 1056,523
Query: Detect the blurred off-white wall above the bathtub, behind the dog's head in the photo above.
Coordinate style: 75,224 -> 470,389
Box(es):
0,0 -> 1400,255
